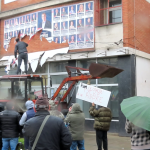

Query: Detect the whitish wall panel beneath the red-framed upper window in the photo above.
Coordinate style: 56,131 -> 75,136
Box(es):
95,23 -> 123,50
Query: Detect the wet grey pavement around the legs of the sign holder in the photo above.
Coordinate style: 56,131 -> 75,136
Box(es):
84,131 -> 131,150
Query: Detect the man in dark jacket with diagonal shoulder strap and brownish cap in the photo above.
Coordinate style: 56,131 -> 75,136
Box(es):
23,97 -> 72,150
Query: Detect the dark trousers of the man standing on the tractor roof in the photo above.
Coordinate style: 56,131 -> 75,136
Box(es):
17,53 -> 28,74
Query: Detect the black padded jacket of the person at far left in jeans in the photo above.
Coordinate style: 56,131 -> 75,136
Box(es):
0,110 -> 20,138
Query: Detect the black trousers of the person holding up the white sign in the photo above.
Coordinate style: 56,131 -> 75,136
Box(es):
96,130 -> 108,150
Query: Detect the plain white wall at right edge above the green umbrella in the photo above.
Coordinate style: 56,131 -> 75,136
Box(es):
136,56 -> 150,97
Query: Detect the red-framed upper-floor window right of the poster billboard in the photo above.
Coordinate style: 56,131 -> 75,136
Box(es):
96,0 -> 122,26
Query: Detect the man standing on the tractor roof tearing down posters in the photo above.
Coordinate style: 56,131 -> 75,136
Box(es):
14,38 -> 28,74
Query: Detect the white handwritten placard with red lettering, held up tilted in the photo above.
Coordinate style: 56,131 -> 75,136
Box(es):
76,83 -> 111,107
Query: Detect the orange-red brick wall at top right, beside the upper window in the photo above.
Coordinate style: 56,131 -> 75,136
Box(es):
122,0 -> 150,53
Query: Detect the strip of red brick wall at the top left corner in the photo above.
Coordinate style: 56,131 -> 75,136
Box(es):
1,0 -> 47,11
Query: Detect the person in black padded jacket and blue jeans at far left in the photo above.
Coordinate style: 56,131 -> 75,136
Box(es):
0,102 -> 20,150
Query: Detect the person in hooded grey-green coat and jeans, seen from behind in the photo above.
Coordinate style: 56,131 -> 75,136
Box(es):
65,103 -> 85,150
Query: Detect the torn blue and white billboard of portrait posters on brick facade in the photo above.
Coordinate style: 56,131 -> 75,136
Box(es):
4,1 -> 94,50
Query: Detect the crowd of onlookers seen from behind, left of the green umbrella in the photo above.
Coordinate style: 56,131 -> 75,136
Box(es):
0,97 -> 112,150
